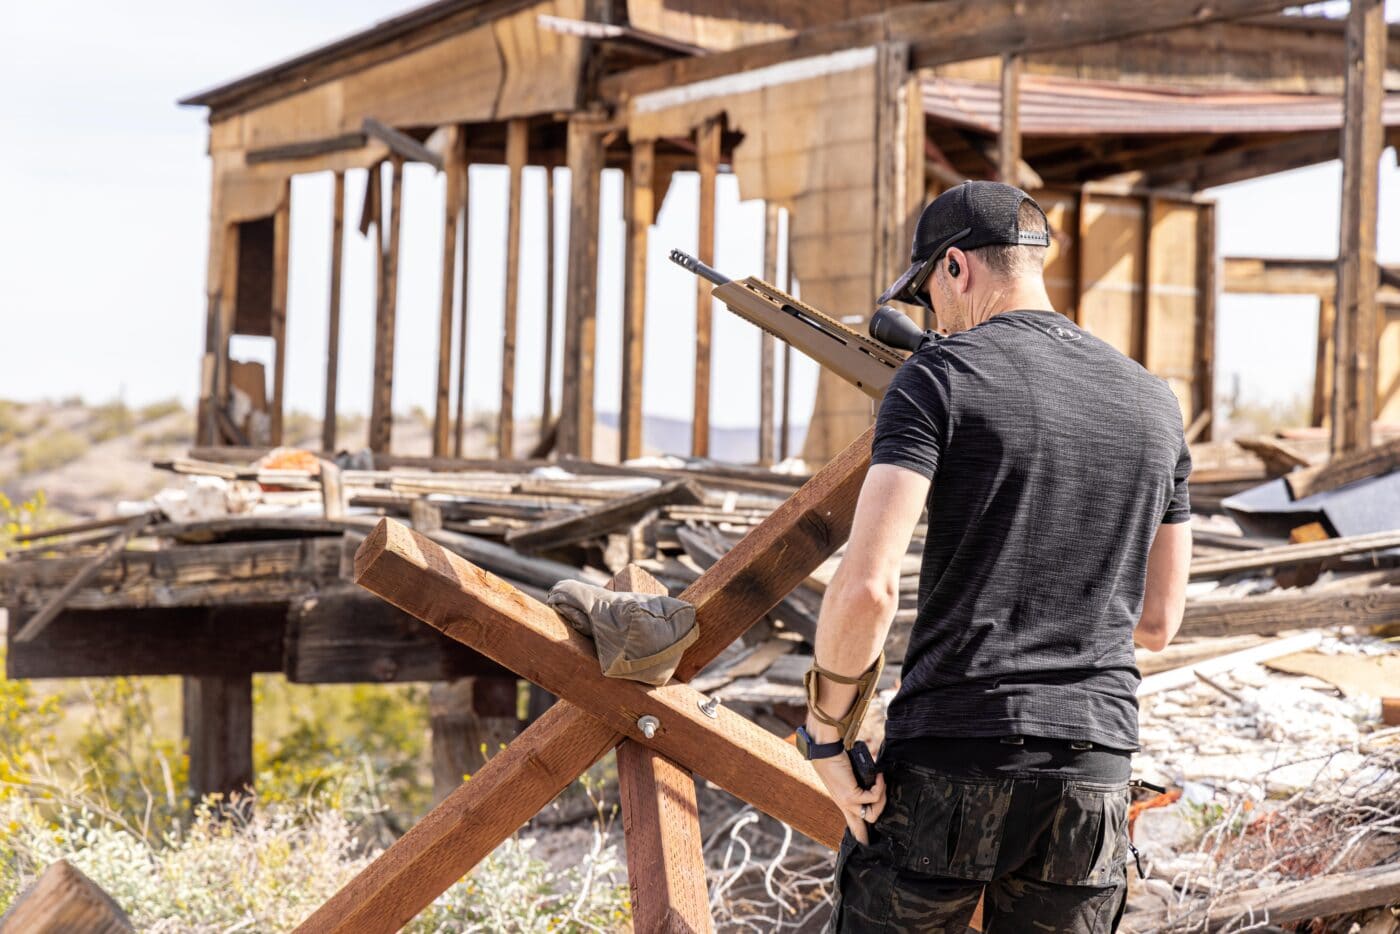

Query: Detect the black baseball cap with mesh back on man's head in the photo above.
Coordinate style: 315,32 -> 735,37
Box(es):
875,182 -> 1050,305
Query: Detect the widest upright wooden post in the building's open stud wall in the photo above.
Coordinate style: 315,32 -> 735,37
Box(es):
556,116 -> 603,459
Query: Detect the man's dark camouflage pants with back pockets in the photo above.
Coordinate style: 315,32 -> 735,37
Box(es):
829,762 -> 1128,934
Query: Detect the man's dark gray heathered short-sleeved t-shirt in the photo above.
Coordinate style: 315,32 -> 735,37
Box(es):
871,311 -> 1191,749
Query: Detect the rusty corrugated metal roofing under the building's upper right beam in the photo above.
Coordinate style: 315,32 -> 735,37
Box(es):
923,74 -> 1400,136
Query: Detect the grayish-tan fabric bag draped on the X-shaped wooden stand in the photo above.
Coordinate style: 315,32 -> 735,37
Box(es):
547,581 -> 700,685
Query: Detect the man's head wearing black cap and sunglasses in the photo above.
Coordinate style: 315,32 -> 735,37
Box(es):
879,182 -> 1050,333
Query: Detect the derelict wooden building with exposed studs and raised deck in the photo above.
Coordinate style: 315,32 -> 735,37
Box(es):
0,0 -> 1400,930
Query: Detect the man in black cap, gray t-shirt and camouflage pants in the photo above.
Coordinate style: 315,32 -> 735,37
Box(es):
799,182 -> 1191,934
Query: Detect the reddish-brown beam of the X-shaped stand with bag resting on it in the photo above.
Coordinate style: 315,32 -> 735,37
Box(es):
356,520 -> 844,847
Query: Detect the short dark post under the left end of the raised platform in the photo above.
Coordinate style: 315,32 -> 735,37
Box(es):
182,674 -> 253,800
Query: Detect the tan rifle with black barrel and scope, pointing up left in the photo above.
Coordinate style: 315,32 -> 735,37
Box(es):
671,249 -> 934,399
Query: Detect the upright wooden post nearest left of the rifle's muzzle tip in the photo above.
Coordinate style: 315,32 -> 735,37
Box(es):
617,140 -> 655,461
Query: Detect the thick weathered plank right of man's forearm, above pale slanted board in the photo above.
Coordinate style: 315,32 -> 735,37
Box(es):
1180,587 -> 1400,637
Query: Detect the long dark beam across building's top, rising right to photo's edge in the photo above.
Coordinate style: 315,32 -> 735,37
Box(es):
599,0 -> 1292,102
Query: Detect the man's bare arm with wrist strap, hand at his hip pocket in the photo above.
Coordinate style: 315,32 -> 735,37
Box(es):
806,463 -> 930,843
